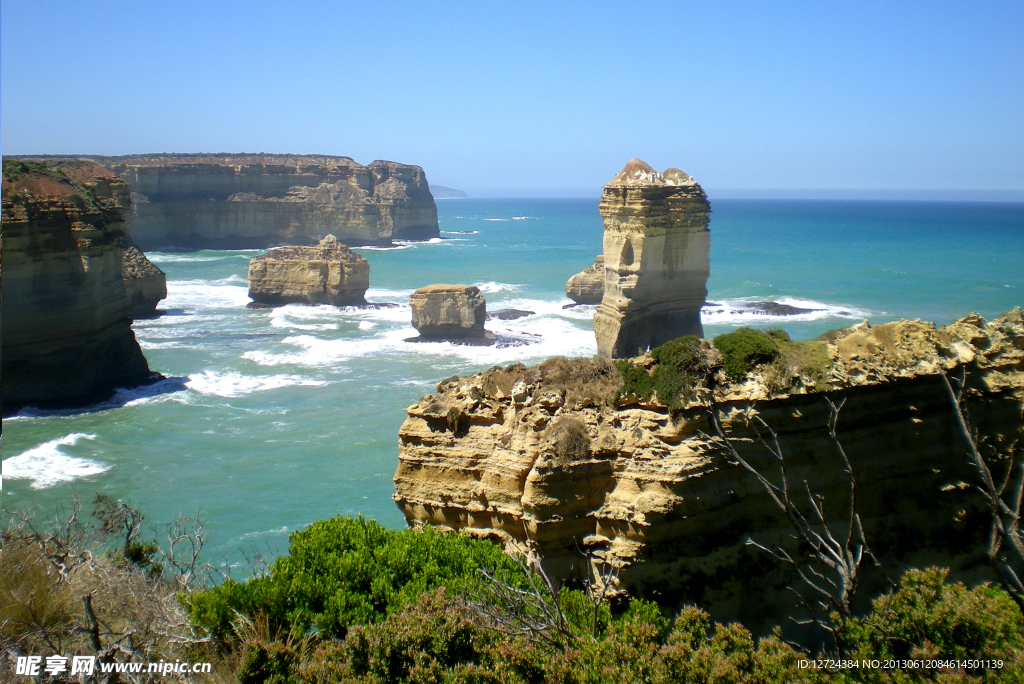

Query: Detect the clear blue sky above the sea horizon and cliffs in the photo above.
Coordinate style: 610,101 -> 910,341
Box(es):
0,0 -> 1024,199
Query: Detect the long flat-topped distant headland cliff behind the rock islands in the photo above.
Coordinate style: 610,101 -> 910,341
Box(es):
72,155 -> 439,250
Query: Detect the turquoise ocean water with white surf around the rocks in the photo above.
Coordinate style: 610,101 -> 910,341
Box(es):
2,200 -> 1024,565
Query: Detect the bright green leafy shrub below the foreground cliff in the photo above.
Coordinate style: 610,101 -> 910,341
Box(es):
186,516 -> 514,640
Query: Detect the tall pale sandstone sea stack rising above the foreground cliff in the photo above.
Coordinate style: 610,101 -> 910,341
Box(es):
594,159 -> 711,358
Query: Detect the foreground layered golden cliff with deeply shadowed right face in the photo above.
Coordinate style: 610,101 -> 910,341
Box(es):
394,308 -> 1024,628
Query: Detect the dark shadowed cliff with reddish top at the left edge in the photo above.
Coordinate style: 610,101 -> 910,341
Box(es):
2,160 -> 155,415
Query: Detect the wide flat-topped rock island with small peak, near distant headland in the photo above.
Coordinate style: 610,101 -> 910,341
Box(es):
249,236 -> 370,306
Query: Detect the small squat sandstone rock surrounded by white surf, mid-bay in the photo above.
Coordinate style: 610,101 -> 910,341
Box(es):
409,285 -> 487,340
